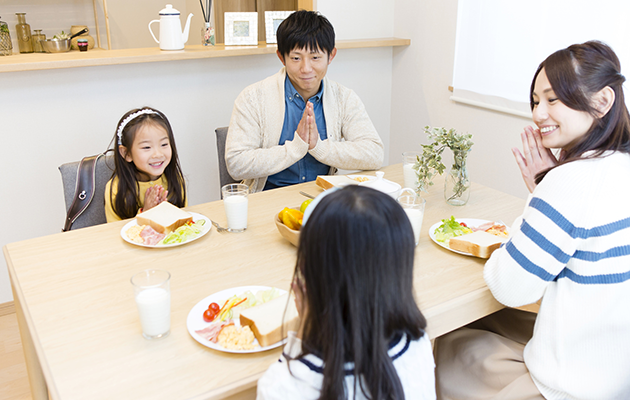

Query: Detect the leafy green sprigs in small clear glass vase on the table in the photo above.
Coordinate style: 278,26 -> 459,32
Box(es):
413,126 -> 474,205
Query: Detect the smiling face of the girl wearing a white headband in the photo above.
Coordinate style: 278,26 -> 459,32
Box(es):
120,123 -> 172,182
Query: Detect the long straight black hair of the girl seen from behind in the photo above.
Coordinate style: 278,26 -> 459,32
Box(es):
294,186 -> 426,400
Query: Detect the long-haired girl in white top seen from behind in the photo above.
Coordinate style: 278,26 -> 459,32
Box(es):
257,186 -> 435,400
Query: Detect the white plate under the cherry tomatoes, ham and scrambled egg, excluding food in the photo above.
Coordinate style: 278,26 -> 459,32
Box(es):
186,286 -> 287,354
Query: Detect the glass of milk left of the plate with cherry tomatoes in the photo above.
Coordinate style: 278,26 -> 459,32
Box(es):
131,269 -> 171,339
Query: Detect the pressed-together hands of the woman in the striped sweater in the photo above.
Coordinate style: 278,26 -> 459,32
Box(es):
512,126 -> 558,192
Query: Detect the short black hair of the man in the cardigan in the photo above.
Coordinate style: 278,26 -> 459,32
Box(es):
276,10 -> 335,58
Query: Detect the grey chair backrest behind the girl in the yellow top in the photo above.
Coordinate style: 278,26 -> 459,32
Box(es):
59,155 -> 114,229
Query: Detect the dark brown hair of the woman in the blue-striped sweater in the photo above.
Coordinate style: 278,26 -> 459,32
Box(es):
529,41 -> 630,183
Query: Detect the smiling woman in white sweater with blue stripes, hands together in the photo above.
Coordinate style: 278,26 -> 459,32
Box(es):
436,41 -> 630,400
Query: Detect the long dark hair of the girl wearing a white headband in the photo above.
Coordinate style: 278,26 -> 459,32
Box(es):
109,107 -> 186,219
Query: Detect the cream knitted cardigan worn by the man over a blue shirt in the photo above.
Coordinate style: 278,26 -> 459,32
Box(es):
225,67 -> 384,192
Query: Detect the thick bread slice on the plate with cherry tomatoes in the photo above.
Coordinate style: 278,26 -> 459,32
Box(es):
240,293 -> 300,347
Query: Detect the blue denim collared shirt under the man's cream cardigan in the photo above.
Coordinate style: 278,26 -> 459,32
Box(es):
263,76 -> 330,190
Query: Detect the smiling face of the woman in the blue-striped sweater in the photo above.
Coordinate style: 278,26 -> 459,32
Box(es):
532,68 -> 595,149
